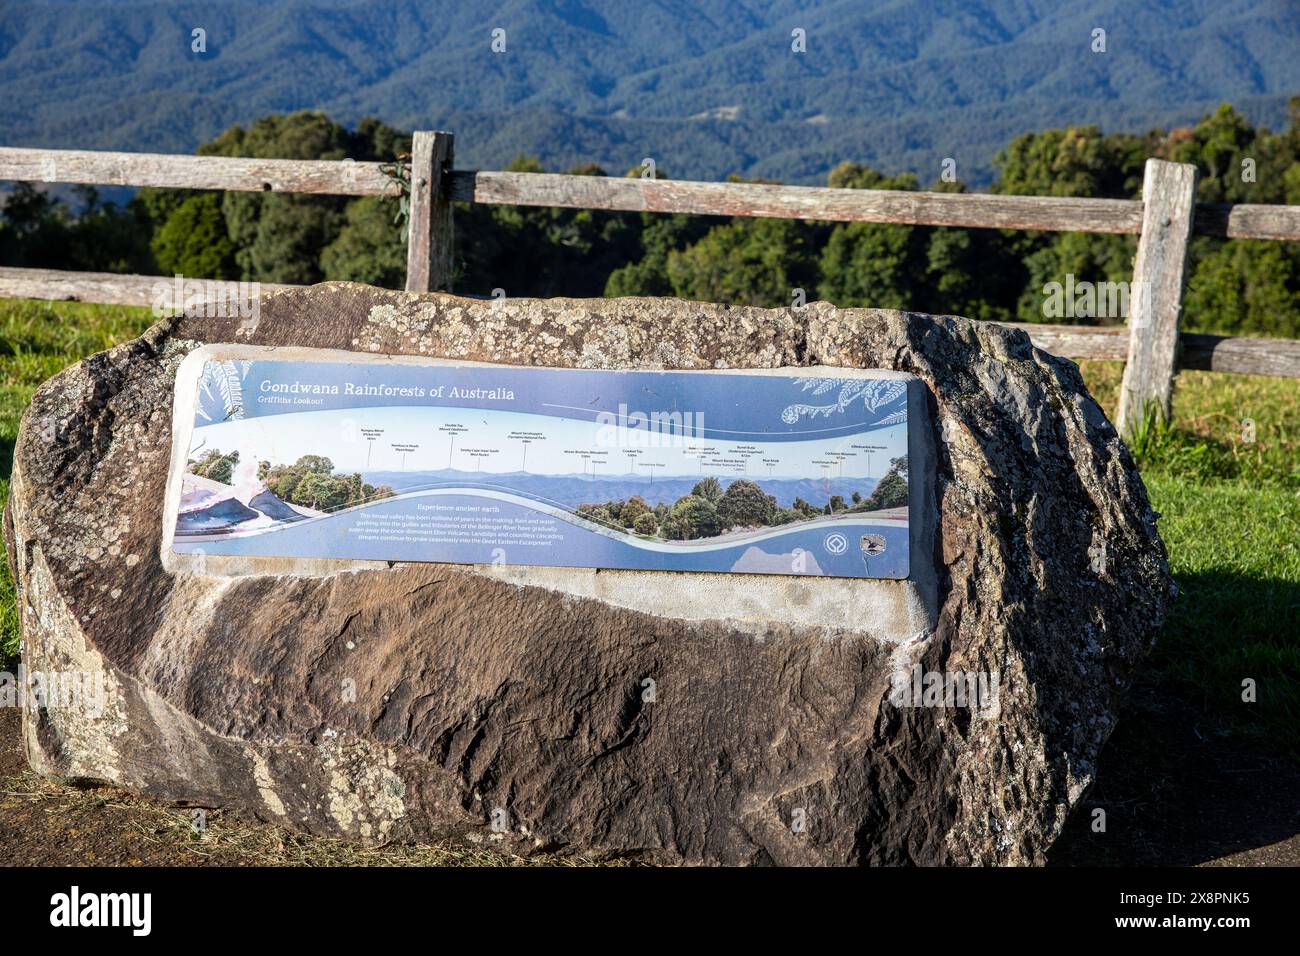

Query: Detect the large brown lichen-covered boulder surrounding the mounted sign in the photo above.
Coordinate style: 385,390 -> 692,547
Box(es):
4,284 -> 1173,864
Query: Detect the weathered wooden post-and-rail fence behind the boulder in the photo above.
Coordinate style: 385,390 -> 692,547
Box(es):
0,131 -> 1300,429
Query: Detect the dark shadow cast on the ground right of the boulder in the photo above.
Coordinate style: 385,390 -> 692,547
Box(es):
1048,572 -> 1300,866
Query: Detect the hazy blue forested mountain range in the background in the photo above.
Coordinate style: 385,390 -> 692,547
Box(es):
0,0 -> 1300,186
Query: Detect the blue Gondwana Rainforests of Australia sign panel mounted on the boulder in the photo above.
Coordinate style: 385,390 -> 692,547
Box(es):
165,346 -> 909,578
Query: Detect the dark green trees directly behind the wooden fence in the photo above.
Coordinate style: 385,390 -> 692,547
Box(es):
0,98 -> 1300,337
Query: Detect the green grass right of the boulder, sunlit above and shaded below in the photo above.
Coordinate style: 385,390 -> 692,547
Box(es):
1082,362 -> 1300,757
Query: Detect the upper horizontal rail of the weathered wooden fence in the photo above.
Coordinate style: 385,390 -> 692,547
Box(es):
0,147 -> 1300,239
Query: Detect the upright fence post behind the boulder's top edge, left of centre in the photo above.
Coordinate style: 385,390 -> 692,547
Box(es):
407,130 -> 452,293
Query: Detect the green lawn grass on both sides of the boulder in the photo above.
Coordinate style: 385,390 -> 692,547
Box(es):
0,300 -> 1300,754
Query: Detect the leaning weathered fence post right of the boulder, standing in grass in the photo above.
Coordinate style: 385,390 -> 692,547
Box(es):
1118,160 -> 1196,434
